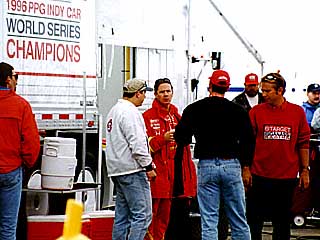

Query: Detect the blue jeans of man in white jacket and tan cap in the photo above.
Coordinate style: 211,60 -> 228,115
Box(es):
112,171 -> 152,240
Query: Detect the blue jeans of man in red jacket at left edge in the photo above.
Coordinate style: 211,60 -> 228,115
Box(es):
0,167 -> 22,240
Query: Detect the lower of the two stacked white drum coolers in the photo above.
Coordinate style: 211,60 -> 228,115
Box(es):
41,155 -> 77,190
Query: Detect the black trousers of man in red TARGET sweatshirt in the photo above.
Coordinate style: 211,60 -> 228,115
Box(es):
247,175 -> 297,240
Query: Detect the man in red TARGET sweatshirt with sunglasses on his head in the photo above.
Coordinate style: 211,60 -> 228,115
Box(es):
243,73 -> 310,240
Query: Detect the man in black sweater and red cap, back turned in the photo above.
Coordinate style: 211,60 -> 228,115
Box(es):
175,70 -> 254,240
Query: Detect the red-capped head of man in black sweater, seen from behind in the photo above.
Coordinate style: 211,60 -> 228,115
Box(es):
209,70 -> 230,94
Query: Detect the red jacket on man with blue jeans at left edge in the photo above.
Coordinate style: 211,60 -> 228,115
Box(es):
0,88 -> 40,173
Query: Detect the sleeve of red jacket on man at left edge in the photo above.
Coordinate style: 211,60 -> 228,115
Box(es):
21,104 -> 40,167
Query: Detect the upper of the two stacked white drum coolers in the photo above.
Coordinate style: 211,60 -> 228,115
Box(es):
43,137 -> 76,157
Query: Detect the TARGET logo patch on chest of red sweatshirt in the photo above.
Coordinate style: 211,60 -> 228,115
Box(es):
263,125 -> 292,141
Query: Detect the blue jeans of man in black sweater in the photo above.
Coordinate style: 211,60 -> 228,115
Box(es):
198,158 -> 250,240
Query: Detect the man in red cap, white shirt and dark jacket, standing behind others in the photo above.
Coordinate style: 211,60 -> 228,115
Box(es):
232,73 -> 263,112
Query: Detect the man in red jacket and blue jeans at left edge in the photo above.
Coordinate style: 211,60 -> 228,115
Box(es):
0,62 -> 40,239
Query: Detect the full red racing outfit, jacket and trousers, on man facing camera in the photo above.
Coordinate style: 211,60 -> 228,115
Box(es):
143,99 -> 196,240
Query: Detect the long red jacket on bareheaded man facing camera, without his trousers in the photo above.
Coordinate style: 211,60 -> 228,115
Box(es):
143,99 -> 197,198
